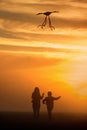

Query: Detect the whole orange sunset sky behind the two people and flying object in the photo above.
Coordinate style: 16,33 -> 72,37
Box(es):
0,0 -> 87,113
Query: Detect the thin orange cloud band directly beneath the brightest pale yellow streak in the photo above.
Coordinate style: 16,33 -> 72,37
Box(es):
0,44 -> 80,55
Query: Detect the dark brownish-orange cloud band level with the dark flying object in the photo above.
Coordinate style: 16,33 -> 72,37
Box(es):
0,6 -> 87,29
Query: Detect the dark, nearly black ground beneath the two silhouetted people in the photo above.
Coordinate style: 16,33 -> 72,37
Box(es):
0,112 -> 87,130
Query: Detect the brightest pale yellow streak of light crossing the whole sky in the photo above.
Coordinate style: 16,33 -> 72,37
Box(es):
0,40 -> 87,52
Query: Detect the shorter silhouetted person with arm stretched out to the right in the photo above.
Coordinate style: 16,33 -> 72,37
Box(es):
43,91 -> 61,119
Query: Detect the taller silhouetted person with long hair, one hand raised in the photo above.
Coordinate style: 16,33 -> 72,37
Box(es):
32,87 -> 44,119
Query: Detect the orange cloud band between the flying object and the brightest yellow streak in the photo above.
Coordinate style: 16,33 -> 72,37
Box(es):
0,26 -> 86,44
